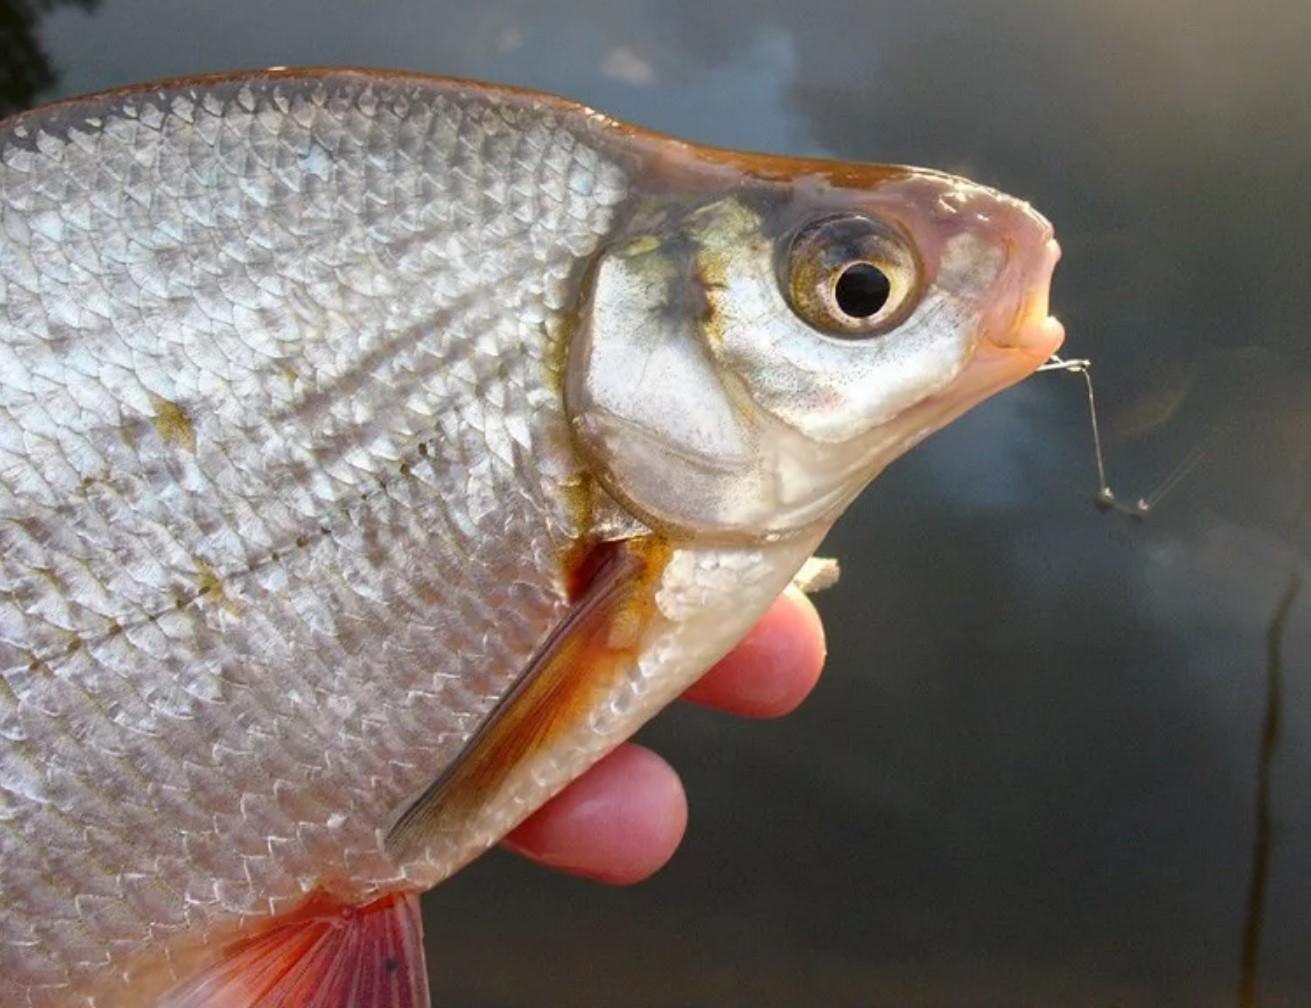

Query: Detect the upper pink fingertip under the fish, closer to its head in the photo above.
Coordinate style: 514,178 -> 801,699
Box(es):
683,587 -> 825,717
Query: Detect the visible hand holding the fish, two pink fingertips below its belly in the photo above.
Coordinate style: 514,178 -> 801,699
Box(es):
502,589 -> 825,885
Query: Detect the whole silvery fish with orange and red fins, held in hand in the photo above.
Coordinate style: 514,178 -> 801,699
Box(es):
0,68 -> 1063,1008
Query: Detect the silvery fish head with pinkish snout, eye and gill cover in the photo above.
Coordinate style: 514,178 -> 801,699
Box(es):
565,163 -> 1063,541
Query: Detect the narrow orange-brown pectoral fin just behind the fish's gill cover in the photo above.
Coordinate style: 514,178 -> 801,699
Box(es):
387,539 -> 669,860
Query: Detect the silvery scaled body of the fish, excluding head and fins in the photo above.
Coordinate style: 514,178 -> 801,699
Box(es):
0,75 -> 625,1007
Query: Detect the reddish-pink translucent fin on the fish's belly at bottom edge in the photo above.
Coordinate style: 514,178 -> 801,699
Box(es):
157,893 -> 429,1008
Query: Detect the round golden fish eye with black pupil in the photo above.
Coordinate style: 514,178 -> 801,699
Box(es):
783,214 -> 919,339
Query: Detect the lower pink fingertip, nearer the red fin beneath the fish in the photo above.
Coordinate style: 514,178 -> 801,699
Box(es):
502,743 -> 687,885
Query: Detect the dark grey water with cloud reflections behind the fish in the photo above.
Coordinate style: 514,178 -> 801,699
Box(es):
0,0 -> 1311,1008
